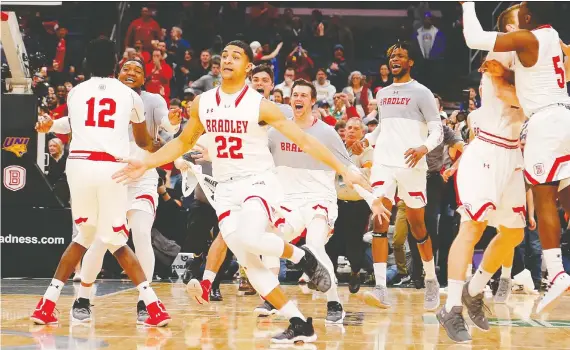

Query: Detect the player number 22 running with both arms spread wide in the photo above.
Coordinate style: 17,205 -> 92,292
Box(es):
115,41 -> 370,343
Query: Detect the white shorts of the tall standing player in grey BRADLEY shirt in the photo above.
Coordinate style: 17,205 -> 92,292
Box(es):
370,164 -> 427,208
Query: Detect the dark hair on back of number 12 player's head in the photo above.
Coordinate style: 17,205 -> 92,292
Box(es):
85,38 -> 117,77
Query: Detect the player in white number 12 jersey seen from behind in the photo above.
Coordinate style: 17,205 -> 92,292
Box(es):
31,39 -> 170,326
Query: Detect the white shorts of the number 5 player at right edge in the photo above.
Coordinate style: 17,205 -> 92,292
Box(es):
523,106 -> 570,189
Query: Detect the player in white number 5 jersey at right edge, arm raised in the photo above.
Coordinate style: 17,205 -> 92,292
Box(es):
463,1 -> 570,312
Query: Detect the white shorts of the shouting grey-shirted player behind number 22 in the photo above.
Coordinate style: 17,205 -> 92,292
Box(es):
275,199 -> 338,242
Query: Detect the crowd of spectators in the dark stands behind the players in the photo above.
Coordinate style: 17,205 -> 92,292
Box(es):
2,2 -> 570,288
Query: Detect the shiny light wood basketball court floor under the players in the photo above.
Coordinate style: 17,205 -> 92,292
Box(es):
1,280 -> 570,350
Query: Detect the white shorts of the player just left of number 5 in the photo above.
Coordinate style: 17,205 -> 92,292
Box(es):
455,137 -> 526,228
